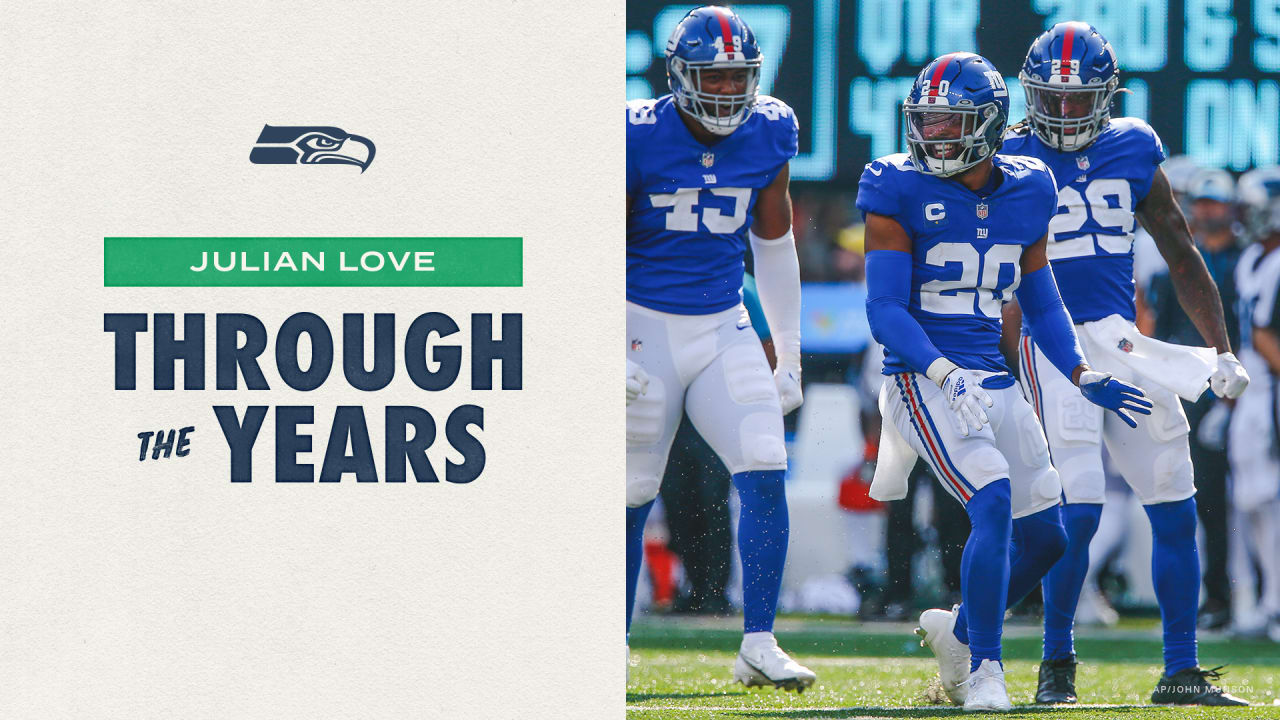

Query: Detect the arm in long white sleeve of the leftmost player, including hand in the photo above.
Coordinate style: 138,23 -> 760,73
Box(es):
748,165 -> 804,415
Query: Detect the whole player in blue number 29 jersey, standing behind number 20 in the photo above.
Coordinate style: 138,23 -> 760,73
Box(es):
1004,22 -> 1249,705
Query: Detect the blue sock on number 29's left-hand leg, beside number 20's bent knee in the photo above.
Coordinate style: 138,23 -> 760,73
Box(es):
1042,502 -> 1102,660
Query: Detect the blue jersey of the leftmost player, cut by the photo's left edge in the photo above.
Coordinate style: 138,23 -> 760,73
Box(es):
627,95 -> 800,315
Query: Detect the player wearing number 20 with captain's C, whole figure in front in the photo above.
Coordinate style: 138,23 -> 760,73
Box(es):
858,53 -> 1148,710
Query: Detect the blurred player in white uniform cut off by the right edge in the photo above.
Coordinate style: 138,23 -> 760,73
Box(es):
1228,167 -> 1280,642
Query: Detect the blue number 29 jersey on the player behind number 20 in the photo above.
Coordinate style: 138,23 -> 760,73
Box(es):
1001,118 -> 1165,323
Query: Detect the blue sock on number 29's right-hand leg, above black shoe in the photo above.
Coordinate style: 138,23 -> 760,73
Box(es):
1143,497 -> 1201,676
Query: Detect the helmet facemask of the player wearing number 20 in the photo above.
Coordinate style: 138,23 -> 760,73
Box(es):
902,97 -> 1000,177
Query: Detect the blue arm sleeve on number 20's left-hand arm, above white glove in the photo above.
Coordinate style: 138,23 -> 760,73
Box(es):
867,250 -> 942,371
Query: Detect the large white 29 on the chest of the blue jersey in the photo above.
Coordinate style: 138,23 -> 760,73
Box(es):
1048,178 -> 1134,260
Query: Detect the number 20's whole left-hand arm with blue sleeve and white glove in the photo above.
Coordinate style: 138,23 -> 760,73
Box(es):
865,207 -> 992,436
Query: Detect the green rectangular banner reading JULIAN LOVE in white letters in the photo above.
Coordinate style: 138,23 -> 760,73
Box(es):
102,237 -> 524,287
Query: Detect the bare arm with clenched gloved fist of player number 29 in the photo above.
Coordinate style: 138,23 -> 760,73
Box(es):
1135,168 -> 1249,397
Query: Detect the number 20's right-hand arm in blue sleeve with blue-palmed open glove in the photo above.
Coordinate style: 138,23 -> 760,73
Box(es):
1014,236 -> 1151,428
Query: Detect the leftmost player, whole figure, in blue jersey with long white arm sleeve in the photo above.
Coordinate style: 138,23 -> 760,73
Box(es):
627,6 -> 814,691
